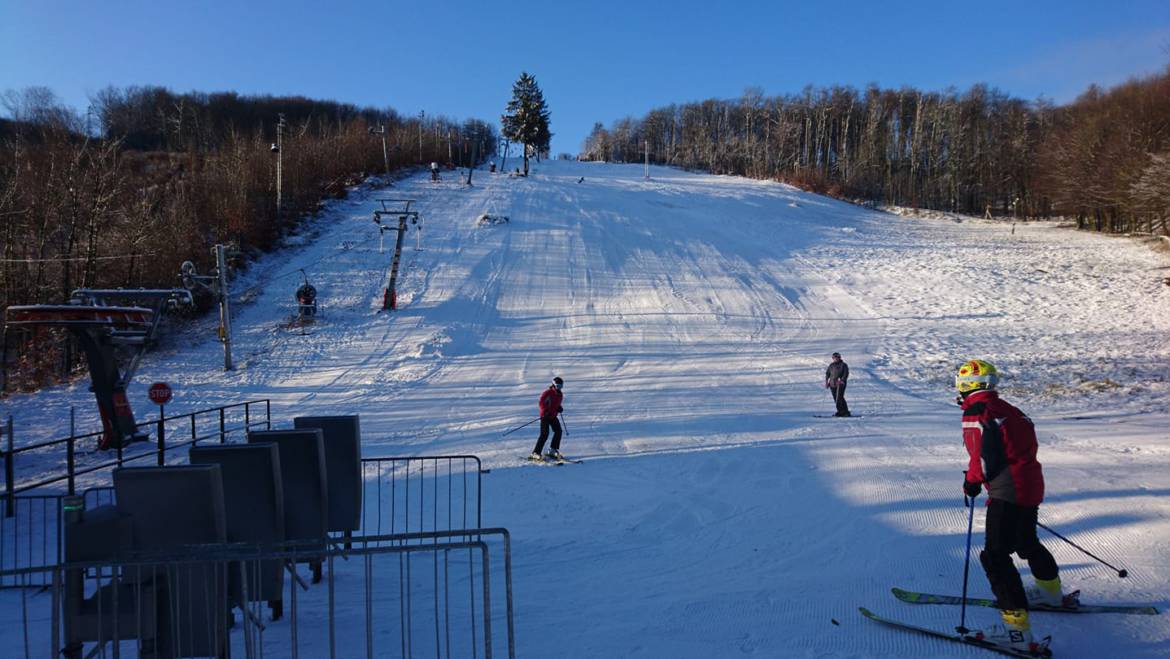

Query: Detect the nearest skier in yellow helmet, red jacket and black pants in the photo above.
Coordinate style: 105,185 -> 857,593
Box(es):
955,359 -> 1064,651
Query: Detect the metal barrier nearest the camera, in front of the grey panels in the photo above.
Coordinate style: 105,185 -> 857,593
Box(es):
0,528 -> 516,659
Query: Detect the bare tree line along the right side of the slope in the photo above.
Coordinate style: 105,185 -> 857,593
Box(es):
580,69 -> 1170,234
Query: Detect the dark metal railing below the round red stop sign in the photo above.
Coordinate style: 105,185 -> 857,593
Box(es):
0,399 -> 271,517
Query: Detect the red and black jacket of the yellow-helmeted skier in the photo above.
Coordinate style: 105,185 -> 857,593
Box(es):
962,391 -> 1044,506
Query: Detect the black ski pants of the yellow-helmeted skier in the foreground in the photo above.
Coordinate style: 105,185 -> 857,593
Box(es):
979,499 -> 1059,610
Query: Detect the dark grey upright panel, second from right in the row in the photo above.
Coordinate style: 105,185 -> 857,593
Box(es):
248,428 -> 329,541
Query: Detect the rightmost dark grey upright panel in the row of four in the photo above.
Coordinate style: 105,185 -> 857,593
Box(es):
293,414 -> 363,531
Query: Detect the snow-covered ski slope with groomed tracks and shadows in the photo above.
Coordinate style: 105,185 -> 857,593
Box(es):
5,163 -> 1170,659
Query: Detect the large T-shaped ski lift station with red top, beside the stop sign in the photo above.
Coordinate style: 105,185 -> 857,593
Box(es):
5,288 -> 192,448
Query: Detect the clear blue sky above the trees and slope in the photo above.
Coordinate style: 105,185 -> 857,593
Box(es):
0,0 -> 1170,153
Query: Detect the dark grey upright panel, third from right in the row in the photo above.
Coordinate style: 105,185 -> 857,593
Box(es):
188,442 -> 284,602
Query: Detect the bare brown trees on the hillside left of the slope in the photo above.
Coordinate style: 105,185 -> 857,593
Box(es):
0,87 -> 498,390
